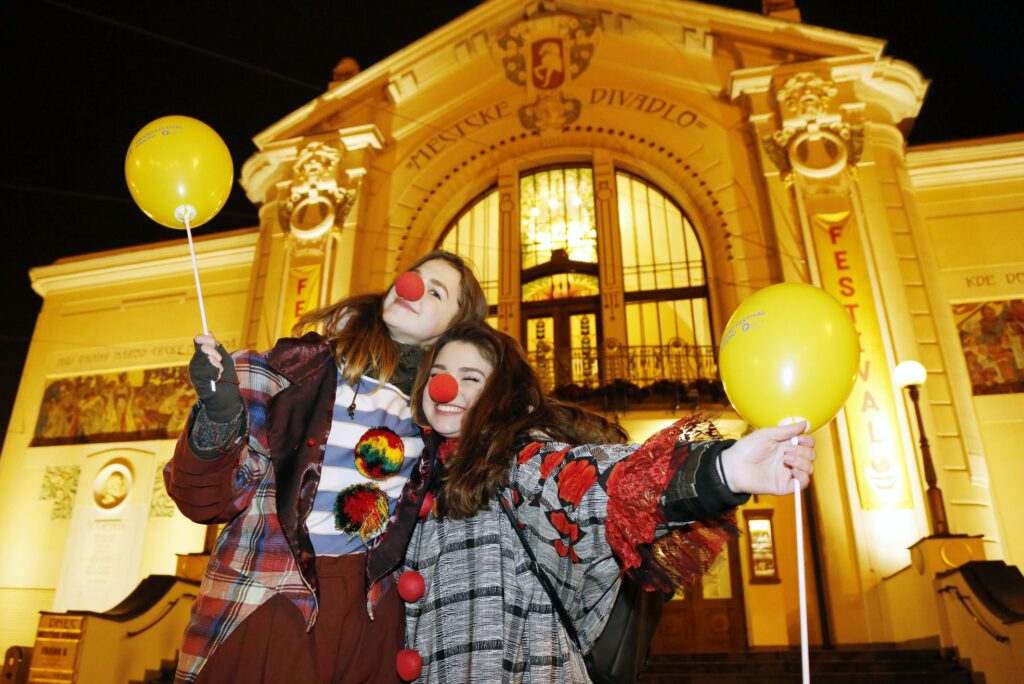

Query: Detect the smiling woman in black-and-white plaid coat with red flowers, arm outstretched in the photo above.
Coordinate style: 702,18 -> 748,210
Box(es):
398,324 -> 815,683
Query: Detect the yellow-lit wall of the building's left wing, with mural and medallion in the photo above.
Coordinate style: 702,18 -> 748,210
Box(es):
0,228 -> 257,650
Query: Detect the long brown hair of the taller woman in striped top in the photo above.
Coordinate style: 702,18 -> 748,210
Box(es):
292,250 -> 487,385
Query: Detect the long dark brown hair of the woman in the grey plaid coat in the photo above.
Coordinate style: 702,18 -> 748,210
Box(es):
412,323 -> 627,518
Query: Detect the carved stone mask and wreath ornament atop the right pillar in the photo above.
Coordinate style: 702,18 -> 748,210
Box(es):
761,73 -> 864,184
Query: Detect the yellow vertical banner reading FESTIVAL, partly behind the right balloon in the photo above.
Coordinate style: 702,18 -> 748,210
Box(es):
811,211 -> 912,510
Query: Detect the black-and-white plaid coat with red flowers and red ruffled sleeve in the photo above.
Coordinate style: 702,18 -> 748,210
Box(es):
406,419 -> 746,684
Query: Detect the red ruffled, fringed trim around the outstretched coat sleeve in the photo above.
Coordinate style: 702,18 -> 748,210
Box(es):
605,417 -> 733,592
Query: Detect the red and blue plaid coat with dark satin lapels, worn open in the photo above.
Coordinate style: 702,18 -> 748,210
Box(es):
164,333 -> 429,682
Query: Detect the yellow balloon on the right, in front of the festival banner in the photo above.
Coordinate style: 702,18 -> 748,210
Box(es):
718,283 -> 860,431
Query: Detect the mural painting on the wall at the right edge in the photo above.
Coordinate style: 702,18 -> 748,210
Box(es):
953,299 -> 1024,394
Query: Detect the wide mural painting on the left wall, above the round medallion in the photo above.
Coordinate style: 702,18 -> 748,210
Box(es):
32,366 -> 196,446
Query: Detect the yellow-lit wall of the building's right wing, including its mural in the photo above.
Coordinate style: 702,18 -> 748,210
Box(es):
907,135 -> 1024,565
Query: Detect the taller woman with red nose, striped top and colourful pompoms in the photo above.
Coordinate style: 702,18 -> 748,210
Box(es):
164,252 -> 486,684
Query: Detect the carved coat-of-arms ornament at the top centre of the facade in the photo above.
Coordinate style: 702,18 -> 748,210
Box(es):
493,2 -> 601,131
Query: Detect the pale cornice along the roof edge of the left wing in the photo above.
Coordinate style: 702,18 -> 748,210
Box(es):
29,228 -> 259,299
